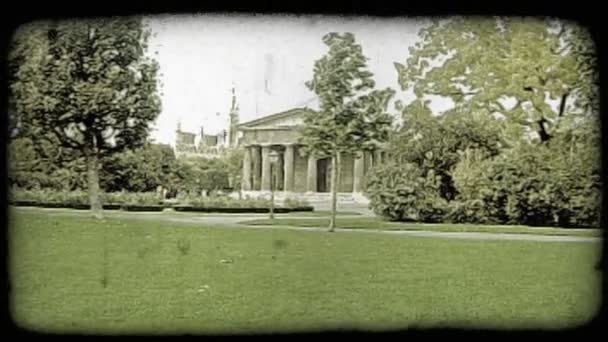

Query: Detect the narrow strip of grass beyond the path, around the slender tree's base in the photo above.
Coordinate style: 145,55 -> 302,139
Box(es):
241,217 -> 601,236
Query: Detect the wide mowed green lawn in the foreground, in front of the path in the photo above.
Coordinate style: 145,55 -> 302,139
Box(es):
9,210 -> 601,334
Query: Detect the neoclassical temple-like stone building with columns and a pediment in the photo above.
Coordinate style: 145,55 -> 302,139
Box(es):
237,108 -> 386,195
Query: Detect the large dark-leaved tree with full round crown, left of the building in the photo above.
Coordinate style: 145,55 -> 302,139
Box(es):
11,18 -> 160,218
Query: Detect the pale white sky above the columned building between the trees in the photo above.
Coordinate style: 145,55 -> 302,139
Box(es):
148,15 -> 436,143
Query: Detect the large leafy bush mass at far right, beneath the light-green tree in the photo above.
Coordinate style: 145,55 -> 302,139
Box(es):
450,120 -> 601,227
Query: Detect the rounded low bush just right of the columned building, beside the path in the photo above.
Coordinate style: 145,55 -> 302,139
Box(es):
366,163 -> 447,222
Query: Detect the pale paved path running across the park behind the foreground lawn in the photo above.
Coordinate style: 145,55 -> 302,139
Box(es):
14,208 -> 601,242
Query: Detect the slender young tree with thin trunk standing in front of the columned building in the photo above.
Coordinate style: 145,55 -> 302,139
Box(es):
301,32 -> 394,231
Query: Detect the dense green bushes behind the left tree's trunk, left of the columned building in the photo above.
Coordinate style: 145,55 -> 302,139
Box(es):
8,138 -> 242,197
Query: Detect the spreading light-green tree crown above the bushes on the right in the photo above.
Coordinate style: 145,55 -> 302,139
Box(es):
395,18 -> 599,141
